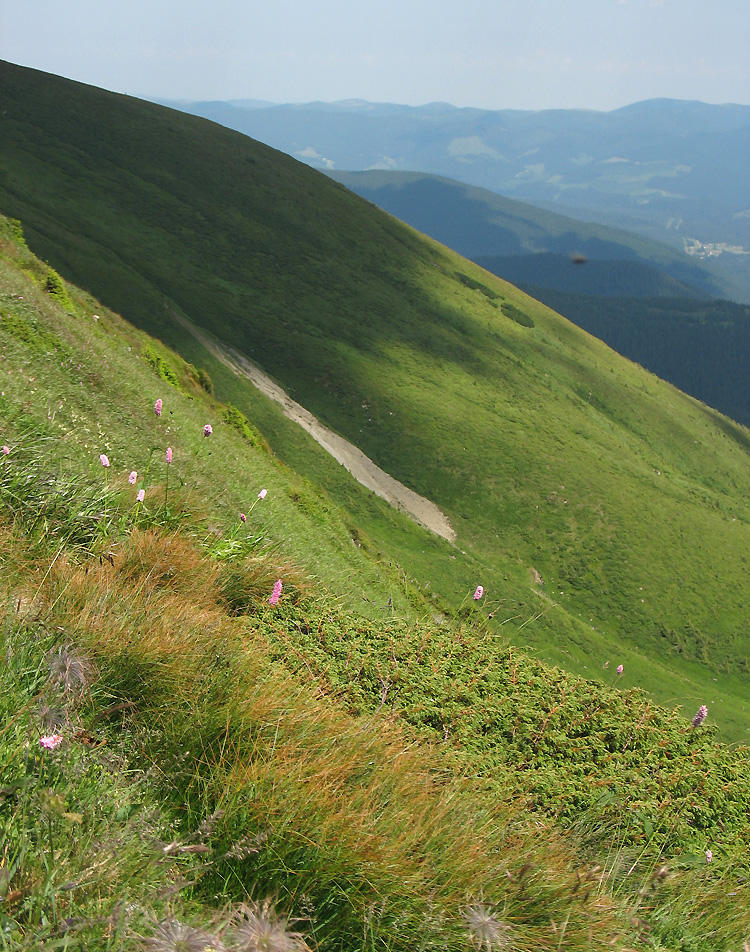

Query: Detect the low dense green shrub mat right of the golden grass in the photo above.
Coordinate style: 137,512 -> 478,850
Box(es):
260,602 -> 750,861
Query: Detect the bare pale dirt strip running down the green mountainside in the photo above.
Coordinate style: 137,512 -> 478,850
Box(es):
172,314 -> 456,542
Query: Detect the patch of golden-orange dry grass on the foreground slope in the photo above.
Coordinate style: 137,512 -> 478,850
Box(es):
14,531 -> 636,950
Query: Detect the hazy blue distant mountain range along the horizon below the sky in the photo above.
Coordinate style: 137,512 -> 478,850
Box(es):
163,92 -> 750,301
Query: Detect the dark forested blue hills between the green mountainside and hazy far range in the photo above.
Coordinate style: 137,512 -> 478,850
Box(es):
328,171 -> 750,425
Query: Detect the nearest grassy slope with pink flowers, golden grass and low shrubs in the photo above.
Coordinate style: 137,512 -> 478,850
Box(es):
0,220 -> 750,952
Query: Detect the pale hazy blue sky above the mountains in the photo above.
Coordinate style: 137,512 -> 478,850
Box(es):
0,0 -> 750,109
